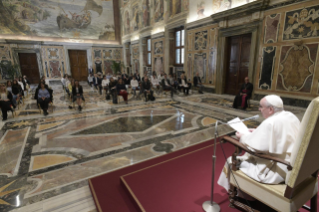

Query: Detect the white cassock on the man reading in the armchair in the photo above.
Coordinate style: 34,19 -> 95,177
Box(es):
239,111 -> 300,184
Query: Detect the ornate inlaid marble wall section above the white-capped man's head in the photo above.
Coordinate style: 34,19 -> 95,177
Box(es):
255,1 -> 319,98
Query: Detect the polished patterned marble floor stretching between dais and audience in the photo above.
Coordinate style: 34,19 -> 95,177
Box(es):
0,84 -> 305,212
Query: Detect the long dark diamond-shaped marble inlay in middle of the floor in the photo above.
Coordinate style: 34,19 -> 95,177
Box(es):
73,116 -> 171,135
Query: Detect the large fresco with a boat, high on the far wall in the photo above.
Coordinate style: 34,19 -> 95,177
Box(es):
0,0 -> 116,41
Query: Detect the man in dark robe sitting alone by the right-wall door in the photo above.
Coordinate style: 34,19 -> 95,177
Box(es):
233,77 -> 254,110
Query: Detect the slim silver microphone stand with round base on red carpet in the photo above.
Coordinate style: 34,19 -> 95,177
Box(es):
203,121 -> 220,212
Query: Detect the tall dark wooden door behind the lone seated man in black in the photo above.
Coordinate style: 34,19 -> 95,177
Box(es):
224,34 -> 251,95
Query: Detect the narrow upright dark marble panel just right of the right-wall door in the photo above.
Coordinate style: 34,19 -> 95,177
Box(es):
258,46 -> 277,90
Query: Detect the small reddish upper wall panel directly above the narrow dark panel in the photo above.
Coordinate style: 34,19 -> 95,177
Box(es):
264,13 -> 281,43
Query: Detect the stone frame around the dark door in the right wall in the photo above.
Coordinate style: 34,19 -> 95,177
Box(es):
216,21 -> 262,94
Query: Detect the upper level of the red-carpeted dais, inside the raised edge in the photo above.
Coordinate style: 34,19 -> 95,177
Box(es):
122,144 -> 238,212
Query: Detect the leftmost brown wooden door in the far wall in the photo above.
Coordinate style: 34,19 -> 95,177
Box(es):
18,53 -> 40,84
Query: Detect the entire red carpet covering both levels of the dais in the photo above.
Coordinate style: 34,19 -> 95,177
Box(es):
89,138 -> 318,212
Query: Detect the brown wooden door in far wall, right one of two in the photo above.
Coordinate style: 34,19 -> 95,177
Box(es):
69,50 -> 88,81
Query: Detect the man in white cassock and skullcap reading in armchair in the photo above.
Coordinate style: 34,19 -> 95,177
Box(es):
217,95 -> 300,191
